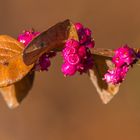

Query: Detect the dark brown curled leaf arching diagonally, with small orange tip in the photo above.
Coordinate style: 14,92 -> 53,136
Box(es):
23,20 -> 78,65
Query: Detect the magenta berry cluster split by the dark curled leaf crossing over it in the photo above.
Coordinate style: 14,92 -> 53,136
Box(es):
17,30 -> 56,71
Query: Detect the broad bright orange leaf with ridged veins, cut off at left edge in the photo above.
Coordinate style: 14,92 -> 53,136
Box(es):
0,35 -> 33,87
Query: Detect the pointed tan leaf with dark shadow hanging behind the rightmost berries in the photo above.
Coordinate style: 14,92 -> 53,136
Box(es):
89,53 -> 120,104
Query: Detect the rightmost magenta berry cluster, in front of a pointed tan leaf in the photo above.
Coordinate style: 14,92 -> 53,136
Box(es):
104,45 -> 138,84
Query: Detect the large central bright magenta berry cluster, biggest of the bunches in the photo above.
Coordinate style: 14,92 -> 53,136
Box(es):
61,23 -> 95,76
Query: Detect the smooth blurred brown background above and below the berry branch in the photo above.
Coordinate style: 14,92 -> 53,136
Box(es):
0,0 -> 140,140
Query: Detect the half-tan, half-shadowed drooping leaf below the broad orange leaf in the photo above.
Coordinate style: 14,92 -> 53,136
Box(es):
0,72 -> 34,109
